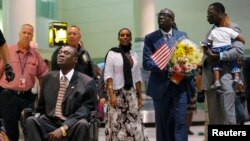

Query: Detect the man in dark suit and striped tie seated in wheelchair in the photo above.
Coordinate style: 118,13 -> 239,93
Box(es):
26,46 -> 97,141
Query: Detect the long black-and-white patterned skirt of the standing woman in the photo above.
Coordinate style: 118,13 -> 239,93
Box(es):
105,88 -> 148,141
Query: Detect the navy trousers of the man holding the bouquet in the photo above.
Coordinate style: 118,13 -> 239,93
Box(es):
153,82 -> 188,141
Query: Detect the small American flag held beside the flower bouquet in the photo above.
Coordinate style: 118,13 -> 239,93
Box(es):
151,44 -> 175,70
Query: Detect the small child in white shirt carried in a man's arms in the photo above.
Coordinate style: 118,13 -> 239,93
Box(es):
203,13 -> 245,89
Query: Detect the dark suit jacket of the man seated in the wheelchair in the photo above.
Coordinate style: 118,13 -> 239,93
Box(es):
36,71 -> 97,127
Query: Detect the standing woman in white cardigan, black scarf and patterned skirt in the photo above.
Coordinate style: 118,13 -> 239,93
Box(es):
104,28 -> 148,141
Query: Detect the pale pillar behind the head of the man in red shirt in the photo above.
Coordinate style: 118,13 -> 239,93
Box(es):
3,0 -> 36,44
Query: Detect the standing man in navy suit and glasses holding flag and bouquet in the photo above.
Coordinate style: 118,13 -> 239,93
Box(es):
143,8 -> 188,141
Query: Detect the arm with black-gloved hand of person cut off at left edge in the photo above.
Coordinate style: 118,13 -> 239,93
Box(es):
0,30 -> 15,82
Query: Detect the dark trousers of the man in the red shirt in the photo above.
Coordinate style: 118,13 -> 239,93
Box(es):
0,88 -> 36,141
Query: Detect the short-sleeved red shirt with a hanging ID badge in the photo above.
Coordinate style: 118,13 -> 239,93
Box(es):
0,44 -> 49,91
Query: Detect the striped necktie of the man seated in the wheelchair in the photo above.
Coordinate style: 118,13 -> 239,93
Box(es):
55,76 -> 67,120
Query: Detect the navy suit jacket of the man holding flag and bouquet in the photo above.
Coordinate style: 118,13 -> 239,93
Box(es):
143,29 -> 187,100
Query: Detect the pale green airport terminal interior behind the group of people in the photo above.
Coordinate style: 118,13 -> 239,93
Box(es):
0,0 -> 250,141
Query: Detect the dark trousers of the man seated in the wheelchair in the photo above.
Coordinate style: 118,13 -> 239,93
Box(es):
26,115 -> 90,141
